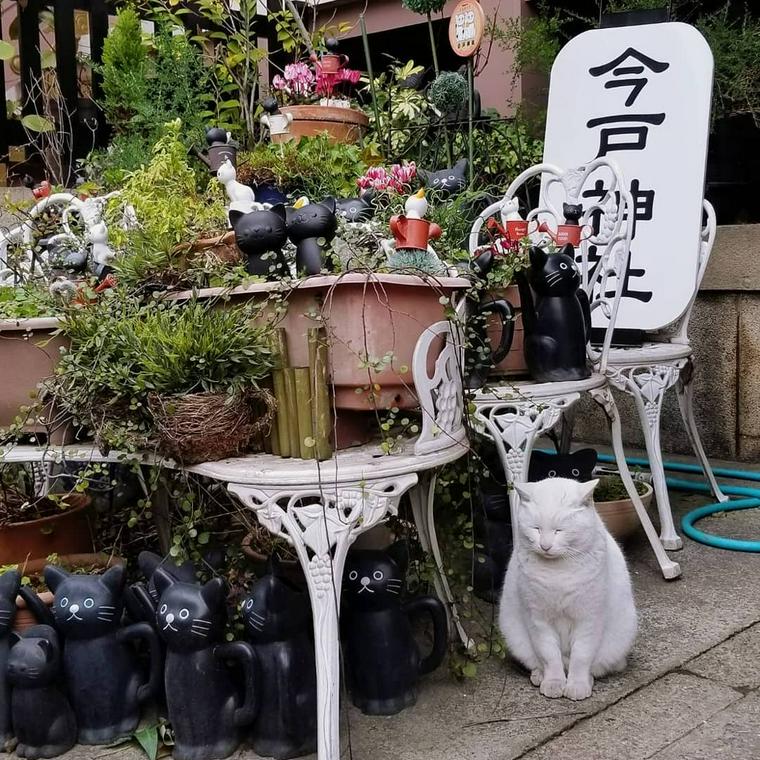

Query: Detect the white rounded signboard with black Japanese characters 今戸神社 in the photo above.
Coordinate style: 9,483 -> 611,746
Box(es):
544,22 -> 713,330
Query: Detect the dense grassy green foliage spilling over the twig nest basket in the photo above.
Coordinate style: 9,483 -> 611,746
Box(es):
47,289 -> 272,450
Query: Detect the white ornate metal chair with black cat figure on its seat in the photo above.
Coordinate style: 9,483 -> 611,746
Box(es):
469,158 -> 681,578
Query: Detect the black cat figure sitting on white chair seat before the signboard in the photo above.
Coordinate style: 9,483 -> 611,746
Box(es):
517,243 -> 591,383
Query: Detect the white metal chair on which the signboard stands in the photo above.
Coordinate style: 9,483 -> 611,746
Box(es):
606,201 -> 728,549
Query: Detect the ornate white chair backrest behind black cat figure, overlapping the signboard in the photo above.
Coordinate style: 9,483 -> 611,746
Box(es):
468,158 -> 633,372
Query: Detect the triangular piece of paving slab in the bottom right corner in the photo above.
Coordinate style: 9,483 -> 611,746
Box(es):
651,692 -> 760,760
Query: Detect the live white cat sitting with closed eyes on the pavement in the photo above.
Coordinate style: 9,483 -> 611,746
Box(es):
499,478 -> 637,699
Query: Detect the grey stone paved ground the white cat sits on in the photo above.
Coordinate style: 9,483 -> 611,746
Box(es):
59,452 -> 760,760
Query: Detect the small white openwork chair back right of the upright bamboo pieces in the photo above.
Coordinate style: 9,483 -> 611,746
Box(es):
412,321 -> 467,454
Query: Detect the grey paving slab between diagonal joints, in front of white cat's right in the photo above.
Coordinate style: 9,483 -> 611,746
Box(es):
523,673 -> 742,760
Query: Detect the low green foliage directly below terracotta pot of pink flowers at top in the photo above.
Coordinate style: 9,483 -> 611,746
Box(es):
238,136 -> 367,201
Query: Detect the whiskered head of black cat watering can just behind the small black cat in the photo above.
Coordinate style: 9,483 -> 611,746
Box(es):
44,565 -> 126,639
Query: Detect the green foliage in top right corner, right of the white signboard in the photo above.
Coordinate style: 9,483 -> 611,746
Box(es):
696,4 -> 760,126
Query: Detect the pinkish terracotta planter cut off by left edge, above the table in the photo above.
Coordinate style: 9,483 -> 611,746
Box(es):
0,317 -> 70,443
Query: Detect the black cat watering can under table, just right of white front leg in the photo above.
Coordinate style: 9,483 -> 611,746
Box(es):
343,541 -> 448,715
